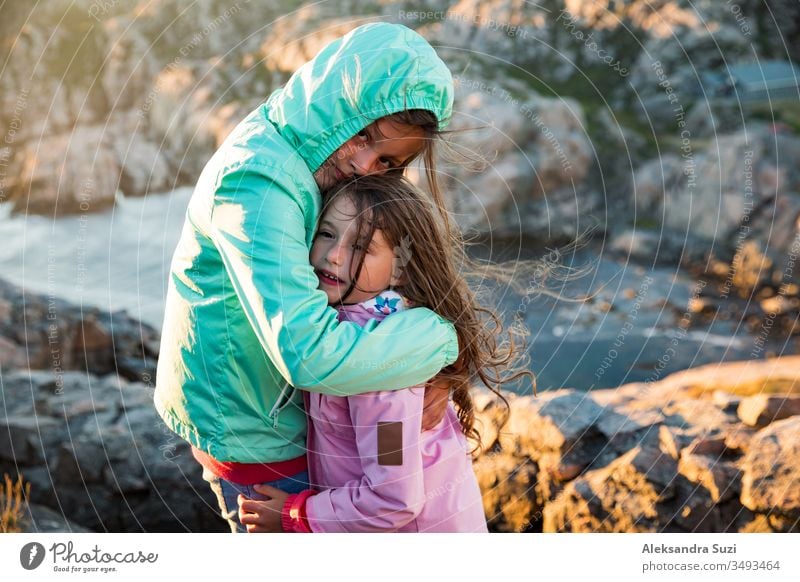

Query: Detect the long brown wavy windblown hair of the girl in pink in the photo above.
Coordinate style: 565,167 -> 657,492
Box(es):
321,173 -> 536,448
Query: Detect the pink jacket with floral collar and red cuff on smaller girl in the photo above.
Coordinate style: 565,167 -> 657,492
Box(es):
283,291 -> 487,532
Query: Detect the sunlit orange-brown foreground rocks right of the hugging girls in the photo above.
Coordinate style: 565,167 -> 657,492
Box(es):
475,356 -> 800,532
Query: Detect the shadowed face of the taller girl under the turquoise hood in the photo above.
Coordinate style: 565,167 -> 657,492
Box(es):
314,117 -> 425,190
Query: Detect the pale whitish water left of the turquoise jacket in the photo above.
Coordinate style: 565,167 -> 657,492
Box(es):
0,188 -> 192,329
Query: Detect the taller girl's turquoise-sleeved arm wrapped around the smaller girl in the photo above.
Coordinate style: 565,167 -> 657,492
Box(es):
210,166 -> 458,395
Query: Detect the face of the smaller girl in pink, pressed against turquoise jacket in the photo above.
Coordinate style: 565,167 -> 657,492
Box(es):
311,196 -> 398,304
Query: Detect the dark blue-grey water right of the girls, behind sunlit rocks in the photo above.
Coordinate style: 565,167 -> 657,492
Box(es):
468,236 -> 792,392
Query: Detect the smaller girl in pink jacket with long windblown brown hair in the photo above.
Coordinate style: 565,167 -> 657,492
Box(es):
239,176 -> 532,532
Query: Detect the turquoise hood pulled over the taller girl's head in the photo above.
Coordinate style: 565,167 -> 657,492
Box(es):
266,22 -> 453,172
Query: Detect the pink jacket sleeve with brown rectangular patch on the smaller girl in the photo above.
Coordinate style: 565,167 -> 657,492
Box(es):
306,387 -> 425,532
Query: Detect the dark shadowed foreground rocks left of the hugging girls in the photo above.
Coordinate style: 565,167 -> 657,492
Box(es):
0,281 -> 225,531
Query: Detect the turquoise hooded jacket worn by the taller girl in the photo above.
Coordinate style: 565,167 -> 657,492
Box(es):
155,23 -> 458,463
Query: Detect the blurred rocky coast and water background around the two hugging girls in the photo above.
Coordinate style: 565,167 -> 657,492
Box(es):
0,0 -> 800,531
